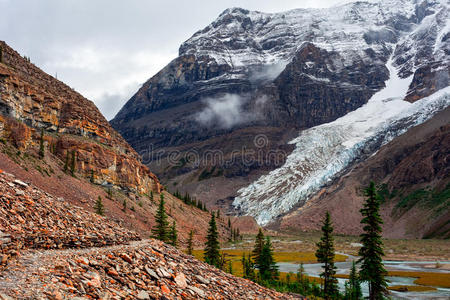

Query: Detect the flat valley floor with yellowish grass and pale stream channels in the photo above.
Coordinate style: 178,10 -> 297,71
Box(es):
200,233 -> 450,299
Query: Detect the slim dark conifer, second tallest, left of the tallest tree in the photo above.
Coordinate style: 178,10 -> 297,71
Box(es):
316,212 -> 338,299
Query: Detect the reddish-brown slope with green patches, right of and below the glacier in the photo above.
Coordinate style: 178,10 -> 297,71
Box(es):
274,108 -> 450,238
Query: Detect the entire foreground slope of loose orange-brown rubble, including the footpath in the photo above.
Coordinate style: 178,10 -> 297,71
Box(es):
0,172 -> 302,300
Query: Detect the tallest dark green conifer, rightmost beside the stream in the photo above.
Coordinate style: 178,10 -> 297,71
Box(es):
358,181 -> 387,300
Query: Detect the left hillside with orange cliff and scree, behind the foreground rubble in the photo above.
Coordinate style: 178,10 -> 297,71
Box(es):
0,42 -> 229,244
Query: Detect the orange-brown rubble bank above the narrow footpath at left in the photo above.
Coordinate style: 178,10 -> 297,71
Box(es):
0,173 -> 140,261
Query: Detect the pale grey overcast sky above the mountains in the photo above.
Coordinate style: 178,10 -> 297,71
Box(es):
0,0 -> 358,120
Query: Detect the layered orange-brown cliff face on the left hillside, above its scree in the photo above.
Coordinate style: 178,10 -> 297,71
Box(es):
0,42 -> 161,193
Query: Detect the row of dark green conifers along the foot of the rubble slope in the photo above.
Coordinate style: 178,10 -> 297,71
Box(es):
152,182 -> 388,300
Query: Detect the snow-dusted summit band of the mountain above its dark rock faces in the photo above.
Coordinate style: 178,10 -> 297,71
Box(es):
179,0 -> 416,71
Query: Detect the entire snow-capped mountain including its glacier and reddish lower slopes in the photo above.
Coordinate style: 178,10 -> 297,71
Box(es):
111,0 -> 450,238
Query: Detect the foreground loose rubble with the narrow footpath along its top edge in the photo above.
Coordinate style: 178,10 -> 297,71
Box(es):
0,240 -> 302,300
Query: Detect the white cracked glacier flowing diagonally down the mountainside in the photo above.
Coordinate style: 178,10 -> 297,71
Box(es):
233,58 -> 450,226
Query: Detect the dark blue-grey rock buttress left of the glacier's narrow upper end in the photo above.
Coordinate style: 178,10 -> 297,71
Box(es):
275,43 -> 389,128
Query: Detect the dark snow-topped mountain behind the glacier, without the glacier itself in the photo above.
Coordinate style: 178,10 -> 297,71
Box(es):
111,0 -> 449,224
